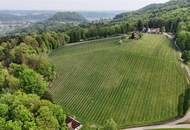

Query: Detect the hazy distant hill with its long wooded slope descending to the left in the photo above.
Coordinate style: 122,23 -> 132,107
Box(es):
7,12 -> 88,35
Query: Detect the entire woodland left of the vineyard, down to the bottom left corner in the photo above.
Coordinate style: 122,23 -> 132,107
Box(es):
0,11 -> 70,130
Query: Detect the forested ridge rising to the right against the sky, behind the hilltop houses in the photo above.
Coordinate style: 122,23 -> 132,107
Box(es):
114,0 -> 190,21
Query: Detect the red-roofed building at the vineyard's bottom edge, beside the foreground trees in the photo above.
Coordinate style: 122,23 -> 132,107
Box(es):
66,116 -> 82,130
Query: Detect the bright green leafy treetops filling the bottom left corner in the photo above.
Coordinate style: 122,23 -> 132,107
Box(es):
0,91 -> 65,130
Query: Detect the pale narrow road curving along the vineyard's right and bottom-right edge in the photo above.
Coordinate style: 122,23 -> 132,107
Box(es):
123,33 -> 190,130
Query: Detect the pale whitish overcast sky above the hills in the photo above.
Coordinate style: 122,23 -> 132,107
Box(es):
0,0 -> 169,11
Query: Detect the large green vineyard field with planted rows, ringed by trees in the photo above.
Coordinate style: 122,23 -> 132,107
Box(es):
50,35 -> 187,127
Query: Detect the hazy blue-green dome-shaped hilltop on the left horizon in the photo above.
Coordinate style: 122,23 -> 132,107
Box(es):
48,12 -> 87,23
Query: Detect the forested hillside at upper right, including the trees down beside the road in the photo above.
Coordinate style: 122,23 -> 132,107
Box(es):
115,0 -> 190,61
